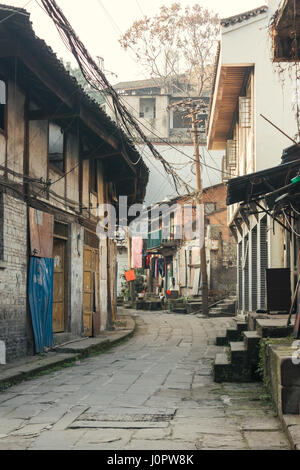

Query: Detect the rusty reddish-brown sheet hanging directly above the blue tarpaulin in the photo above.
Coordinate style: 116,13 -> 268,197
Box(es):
29,207 -> 54,258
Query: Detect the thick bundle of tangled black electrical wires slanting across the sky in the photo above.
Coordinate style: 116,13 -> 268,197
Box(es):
41,0 -> 194,194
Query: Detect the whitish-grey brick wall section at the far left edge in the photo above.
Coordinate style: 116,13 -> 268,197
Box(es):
0,194 -> 27,362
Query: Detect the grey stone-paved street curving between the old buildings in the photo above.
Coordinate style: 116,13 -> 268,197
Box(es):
0,313 -> 289,450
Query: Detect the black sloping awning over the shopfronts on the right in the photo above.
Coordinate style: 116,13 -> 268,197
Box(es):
227,160 -> 300,206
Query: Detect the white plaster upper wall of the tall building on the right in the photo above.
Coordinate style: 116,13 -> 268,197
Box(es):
221,0 -> 297,171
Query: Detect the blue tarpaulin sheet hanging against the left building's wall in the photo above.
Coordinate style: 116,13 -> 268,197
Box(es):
28,258 -> 53,353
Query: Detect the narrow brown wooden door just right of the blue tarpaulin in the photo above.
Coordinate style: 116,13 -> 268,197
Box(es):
53,238 -> 66,333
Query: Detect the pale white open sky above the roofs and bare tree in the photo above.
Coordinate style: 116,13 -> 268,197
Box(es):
1,0 -> 267,84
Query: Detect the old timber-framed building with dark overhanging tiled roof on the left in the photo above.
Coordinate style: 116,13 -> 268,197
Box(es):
0,6 -> 148,360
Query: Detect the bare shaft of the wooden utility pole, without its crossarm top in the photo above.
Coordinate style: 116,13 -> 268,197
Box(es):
192,105 -> 209,315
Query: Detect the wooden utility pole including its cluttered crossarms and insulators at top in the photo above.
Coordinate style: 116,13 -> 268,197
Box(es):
169,99 -> 209,315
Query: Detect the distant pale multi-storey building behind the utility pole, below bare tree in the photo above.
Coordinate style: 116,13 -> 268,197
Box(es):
106,79 -> 224,205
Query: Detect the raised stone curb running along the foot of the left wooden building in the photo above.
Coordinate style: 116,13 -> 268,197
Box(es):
0,315 -> 136,392
